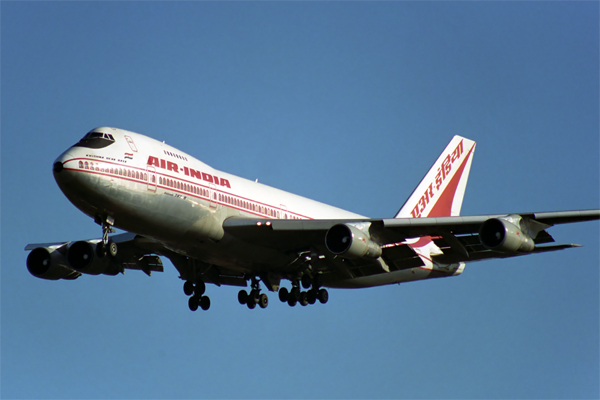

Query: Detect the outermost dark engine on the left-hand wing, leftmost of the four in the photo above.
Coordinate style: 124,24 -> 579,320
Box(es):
27,247 -> 81,280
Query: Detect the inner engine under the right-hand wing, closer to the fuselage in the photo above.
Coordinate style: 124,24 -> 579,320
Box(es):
325,224 -> 381,258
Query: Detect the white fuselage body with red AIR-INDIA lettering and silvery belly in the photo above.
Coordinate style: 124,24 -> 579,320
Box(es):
54,127 -> 464,287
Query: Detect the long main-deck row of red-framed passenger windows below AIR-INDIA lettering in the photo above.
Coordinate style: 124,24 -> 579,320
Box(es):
79,161 -> 300,219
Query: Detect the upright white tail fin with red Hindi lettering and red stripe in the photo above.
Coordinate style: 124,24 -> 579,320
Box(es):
395,135 -> 475,218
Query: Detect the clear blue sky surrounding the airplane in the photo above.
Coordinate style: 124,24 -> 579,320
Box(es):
0,2 -> 600,399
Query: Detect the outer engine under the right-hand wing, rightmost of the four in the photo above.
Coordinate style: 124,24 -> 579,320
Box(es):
479,217 -> 535,253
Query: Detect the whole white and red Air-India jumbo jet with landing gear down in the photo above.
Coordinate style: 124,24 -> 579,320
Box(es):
25,127 -> 600,311
